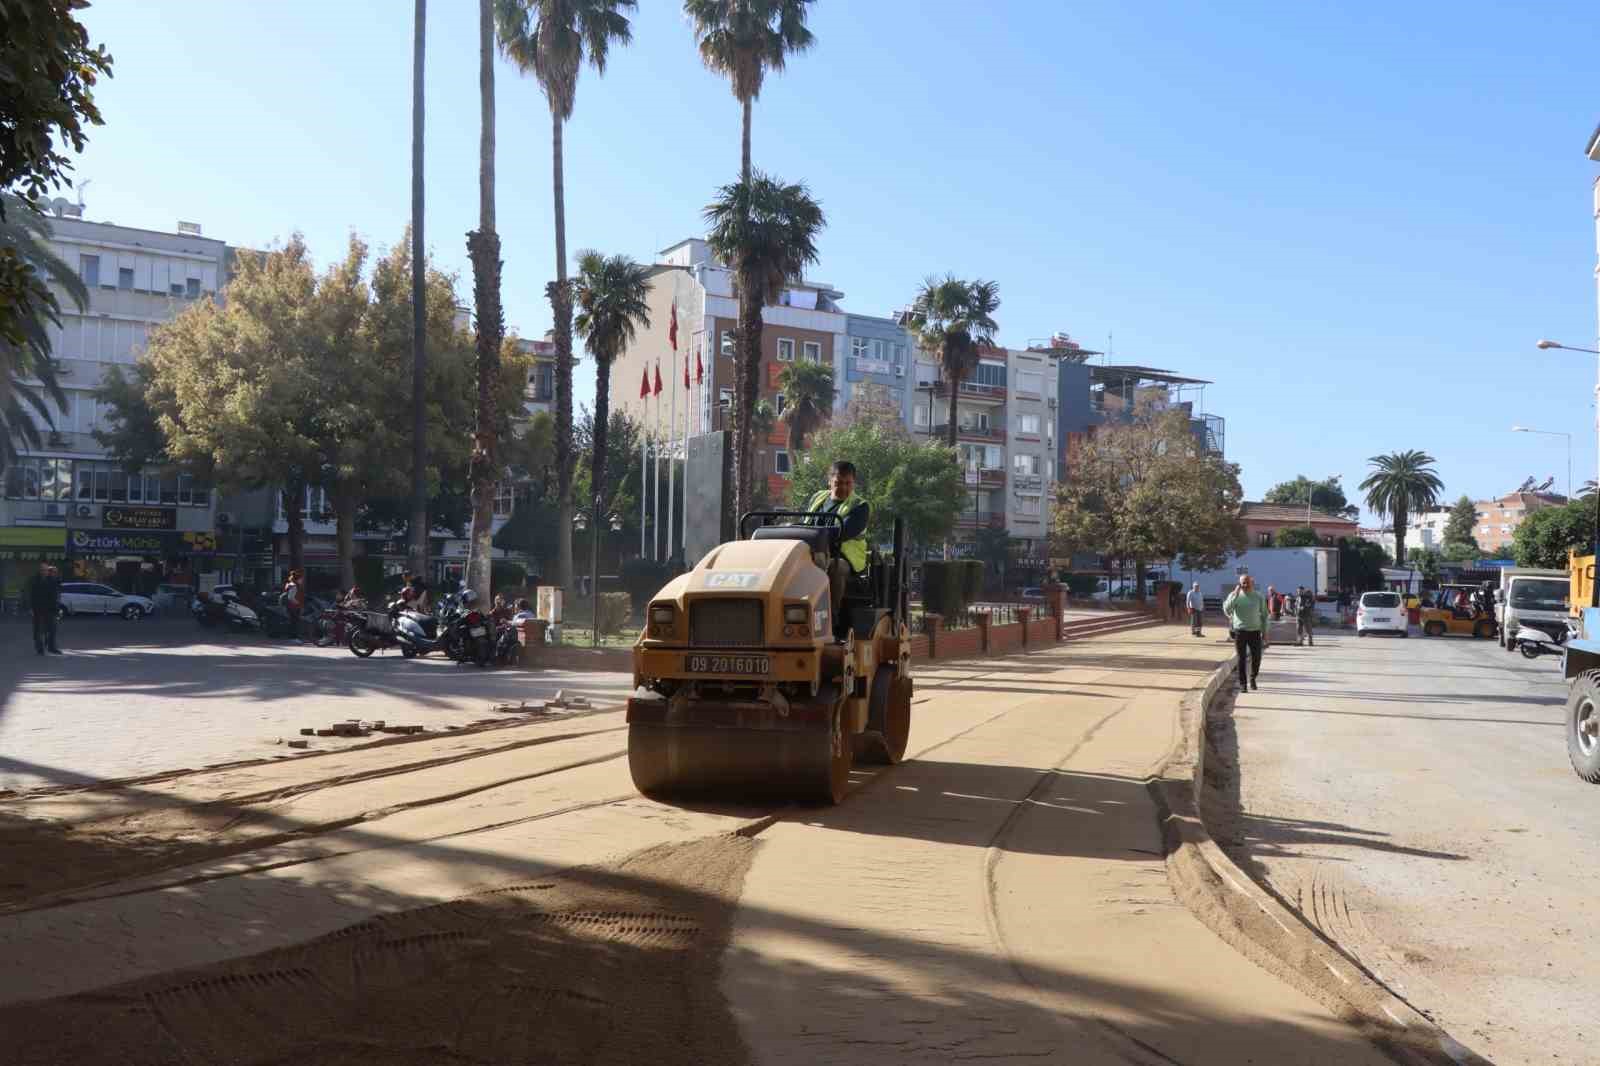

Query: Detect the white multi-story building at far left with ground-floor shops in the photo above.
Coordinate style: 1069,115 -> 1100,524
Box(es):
0,200 -> 229,597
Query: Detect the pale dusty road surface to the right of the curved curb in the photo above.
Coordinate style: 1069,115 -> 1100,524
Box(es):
1206,635 -> 1600,1064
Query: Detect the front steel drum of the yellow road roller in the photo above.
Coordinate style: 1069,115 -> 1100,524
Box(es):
627,711 -> 851,804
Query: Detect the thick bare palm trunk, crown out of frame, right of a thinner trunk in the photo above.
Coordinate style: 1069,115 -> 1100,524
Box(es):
467,0 -> 506,605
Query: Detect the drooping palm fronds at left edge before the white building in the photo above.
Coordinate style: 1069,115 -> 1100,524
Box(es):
0,192 -> 74,467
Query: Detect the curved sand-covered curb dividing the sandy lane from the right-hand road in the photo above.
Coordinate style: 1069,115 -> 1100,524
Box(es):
1147,661 -> 1493,1066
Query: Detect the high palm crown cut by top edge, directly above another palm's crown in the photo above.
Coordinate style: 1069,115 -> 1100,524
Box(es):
683,0 -> 816,184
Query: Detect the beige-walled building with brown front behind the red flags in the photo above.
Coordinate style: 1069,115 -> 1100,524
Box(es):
611,237 -> 848,501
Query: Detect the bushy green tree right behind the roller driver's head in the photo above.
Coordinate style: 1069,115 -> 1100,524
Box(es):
787,421 -> 970,546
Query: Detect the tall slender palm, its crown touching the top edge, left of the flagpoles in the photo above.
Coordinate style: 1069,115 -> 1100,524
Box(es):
494,0 -> 638,587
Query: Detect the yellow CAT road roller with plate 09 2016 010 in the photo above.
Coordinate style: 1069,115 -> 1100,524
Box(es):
627,511 -> 912,804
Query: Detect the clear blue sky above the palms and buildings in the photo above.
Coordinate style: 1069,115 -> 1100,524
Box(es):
68,0 -> 1600,518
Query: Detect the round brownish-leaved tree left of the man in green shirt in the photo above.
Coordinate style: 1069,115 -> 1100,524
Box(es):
1053,403 -> 1246,597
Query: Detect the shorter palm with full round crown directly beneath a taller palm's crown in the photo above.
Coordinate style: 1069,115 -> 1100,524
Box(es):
706,171 -> 826,515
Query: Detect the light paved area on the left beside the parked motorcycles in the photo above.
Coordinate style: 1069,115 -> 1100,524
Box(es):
0,618 -> 632,791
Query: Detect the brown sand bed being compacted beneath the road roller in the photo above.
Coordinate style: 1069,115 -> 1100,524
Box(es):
0,627 -> 1401,1066
